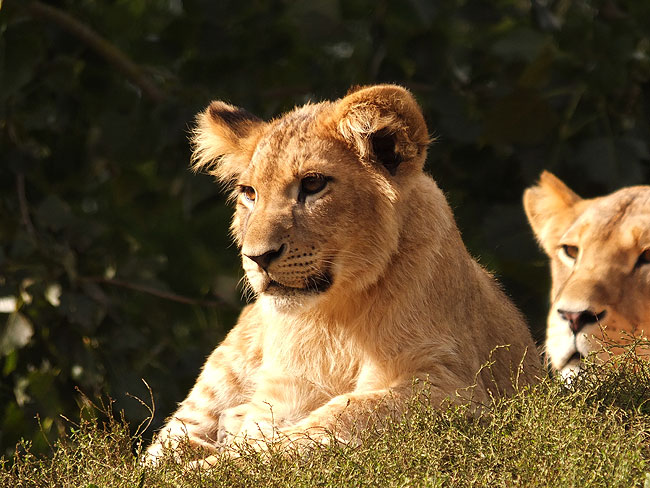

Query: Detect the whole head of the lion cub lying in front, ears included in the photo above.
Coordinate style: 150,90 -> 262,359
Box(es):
193,85 -> 429,308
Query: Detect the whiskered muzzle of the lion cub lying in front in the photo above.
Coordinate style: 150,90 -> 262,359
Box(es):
242,242 -> 332,295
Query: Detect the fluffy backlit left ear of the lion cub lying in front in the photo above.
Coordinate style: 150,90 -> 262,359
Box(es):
192,101 -> 265,183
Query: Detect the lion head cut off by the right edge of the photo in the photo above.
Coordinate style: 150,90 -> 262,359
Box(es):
524,172 -> 650,375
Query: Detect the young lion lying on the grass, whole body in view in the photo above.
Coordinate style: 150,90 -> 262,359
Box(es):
149,85 -> 540,464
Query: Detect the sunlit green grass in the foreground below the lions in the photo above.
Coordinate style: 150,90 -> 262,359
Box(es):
0,357 -> 650,488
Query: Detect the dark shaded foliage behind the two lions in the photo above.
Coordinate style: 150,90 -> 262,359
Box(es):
0,0 -> 650,455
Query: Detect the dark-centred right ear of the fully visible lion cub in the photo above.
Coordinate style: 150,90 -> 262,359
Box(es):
334,85 -> 429,176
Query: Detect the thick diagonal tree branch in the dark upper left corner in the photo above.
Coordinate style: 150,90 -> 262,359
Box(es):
26,0 -> 165,102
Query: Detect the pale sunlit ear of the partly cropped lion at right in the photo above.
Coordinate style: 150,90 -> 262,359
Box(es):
524,171 -> 582,255
